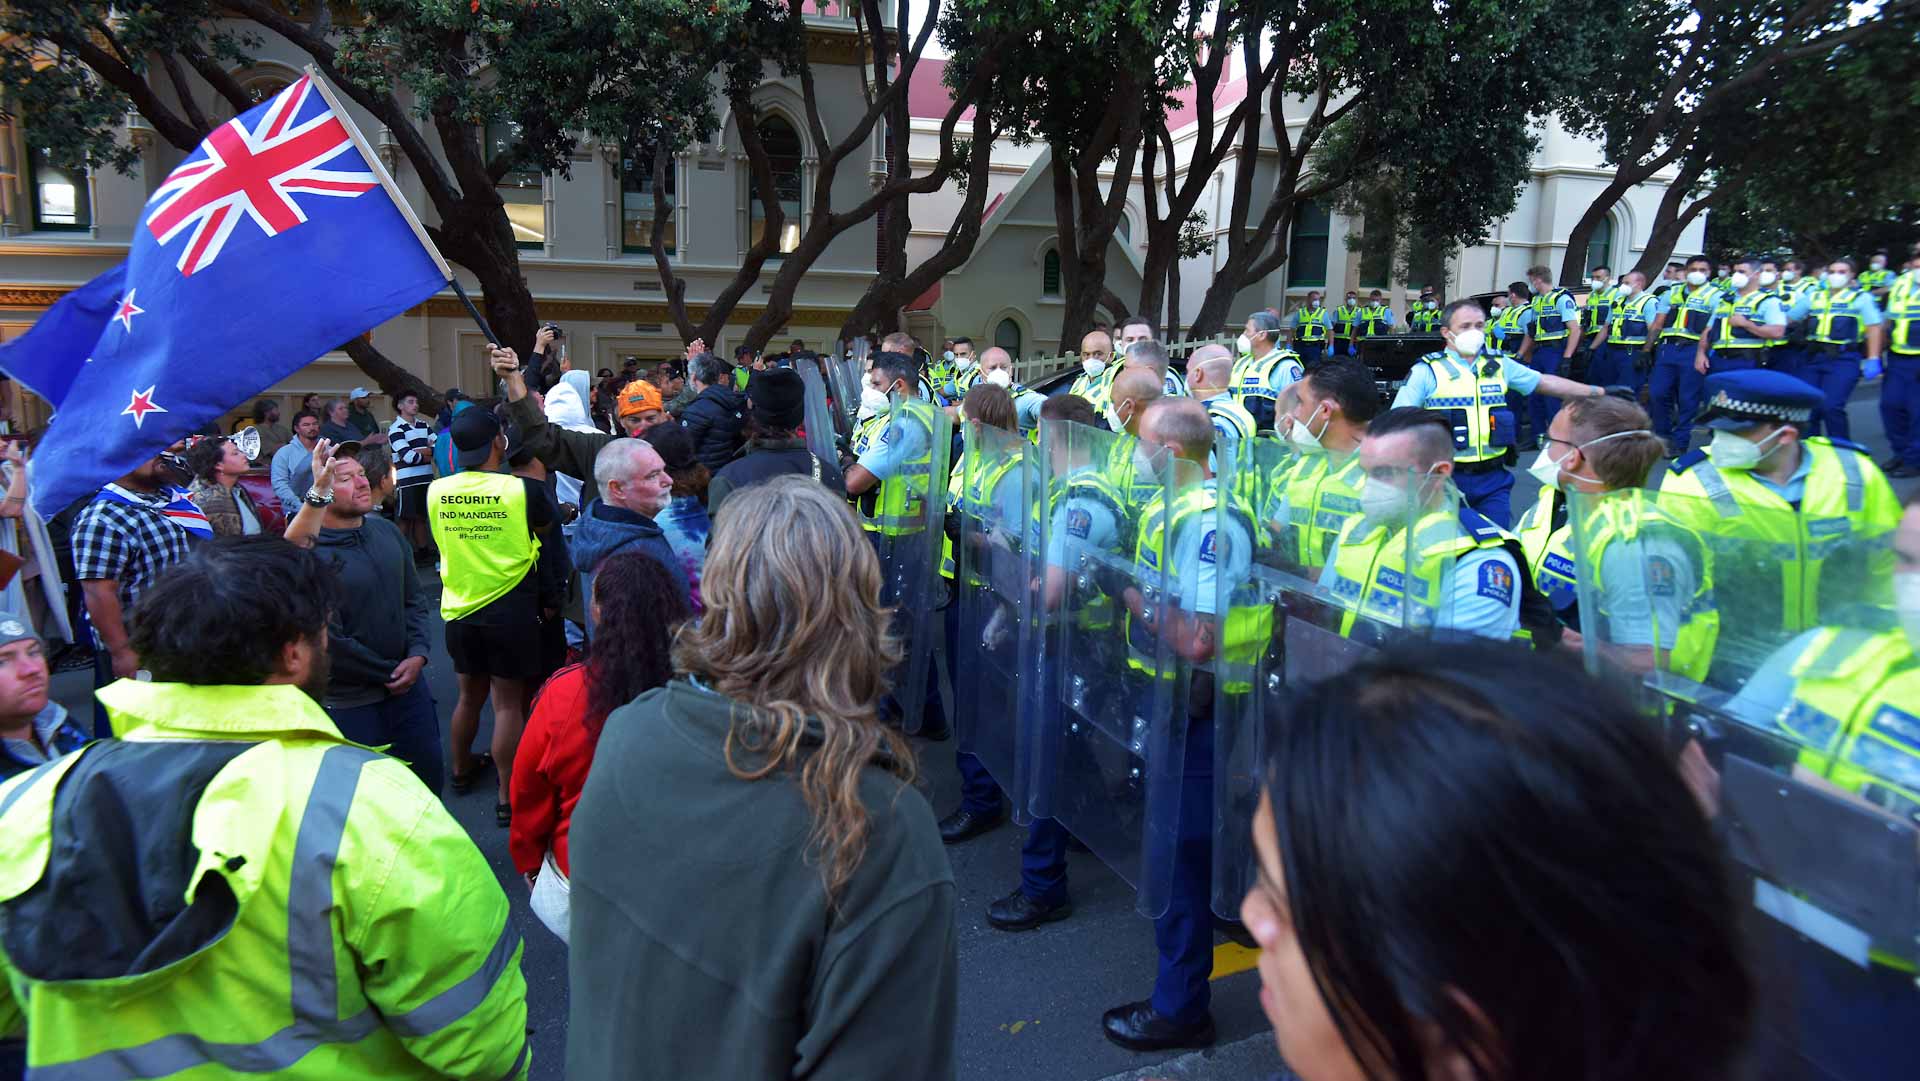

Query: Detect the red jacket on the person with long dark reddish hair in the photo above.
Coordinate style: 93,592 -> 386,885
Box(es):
507,664 -> 607,876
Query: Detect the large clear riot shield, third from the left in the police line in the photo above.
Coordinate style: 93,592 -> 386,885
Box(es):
1027,420 -> 1188,916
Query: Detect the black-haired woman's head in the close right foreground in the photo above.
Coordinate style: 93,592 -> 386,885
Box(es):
1240,643 -> 1755,1081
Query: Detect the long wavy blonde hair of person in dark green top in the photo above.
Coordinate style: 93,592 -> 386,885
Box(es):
674,476 -> 914,901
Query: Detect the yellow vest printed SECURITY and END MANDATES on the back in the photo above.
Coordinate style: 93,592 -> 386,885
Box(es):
426,470 -> 540,622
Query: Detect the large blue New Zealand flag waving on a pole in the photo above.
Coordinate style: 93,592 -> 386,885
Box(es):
0,73 -> 453,516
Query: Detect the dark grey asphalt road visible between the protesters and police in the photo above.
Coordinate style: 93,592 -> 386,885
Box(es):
41,386 -> 1920,1081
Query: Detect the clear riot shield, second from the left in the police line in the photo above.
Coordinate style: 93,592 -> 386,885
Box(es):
947,422 -> 1041,822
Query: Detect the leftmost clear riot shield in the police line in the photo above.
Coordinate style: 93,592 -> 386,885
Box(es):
868,397 -> 952,733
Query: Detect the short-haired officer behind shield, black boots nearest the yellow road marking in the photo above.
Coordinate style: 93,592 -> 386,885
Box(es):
1102,397 -> 1254,1050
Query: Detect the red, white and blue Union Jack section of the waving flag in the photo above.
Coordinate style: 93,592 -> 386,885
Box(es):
146,75 -> 380,275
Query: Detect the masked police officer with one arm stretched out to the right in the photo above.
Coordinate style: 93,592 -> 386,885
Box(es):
1394,300 -> 1605,528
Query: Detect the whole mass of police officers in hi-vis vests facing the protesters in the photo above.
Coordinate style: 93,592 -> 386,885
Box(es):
829,252 -> 1920,1077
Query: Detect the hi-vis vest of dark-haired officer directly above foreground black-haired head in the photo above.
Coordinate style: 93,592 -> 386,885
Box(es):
1332,503 -> 1521,637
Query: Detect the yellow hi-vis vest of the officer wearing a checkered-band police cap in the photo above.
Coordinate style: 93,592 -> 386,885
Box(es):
1661,438 -> 1901,632
